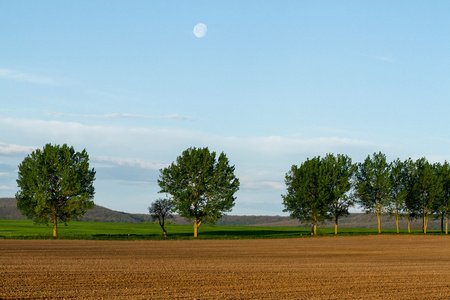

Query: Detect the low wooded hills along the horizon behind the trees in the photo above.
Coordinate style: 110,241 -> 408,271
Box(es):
0,198 -> 440,229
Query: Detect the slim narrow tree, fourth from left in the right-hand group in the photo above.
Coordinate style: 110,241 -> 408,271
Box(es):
387,158 -> 408,233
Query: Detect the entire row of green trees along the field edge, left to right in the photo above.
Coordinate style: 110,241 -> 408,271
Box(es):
16,144 -> 450,237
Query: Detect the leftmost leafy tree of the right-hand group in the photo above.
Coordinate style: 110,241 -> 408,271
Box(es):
281,157 -> 333,235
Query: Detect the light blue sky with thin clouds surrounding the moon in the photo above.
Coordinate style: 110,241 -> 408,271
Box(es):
0,0 -> 450,215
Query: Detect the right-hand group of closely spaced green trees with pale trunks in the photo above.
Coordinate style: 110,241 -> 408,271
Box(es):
282,152 -> 450,235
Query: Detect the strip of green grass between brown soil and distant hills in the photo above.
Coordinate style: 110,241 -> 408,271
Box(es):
0,220 -> 439,240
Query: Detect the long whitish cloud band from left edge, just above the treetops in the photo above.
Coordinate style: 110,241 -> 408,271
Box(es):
0,117 -> 391,168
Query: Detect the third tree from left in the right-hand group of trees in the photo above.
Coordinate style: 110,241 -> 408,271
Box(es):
356,152 -> 390,233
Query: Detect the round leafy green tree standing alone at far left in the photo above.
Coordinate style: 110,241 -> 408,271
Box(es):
16,144 -> 95,237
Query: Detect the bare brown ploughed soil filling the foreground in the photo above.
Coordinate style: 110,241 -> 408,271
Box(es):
0,235 -> 450,299
